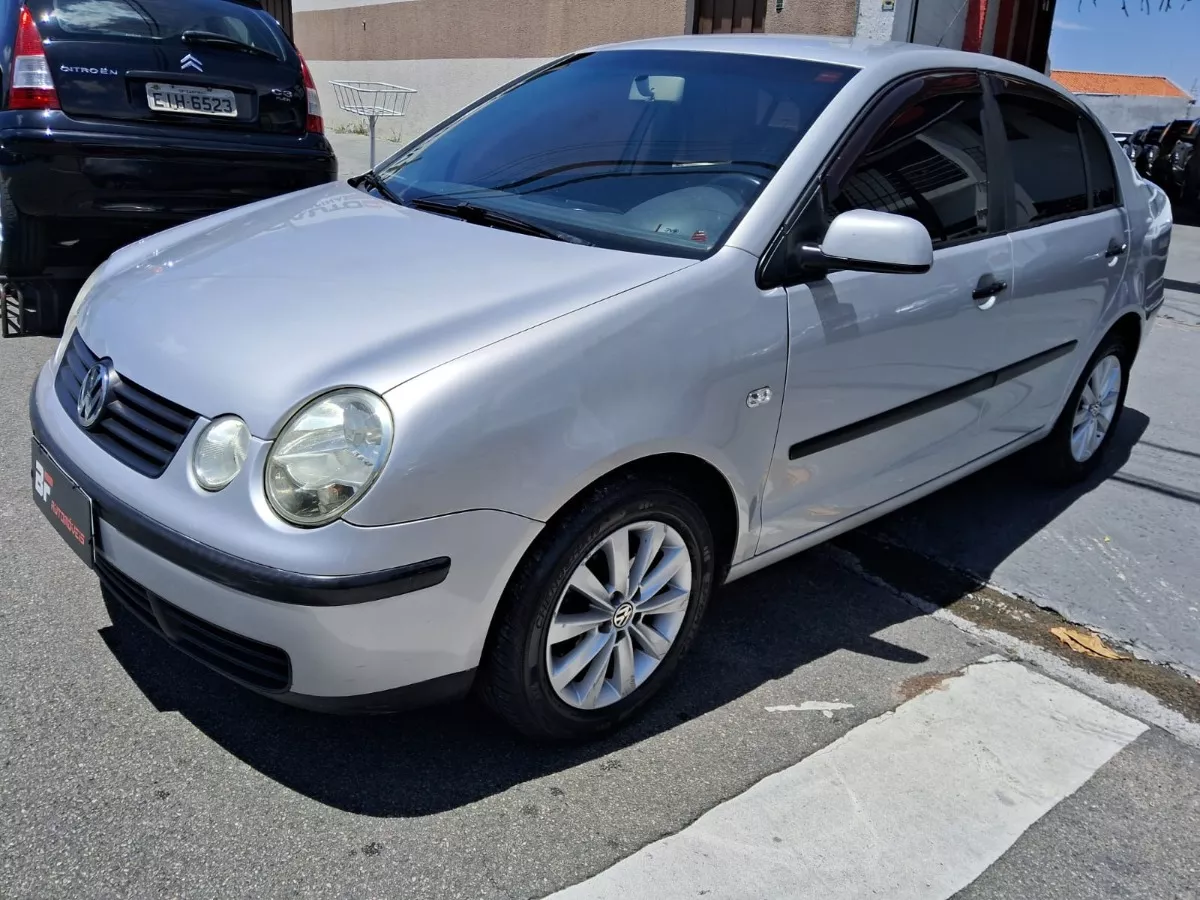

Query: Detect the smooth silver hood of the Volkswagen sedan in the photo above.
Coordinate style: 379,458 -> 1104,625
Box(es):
78,182 -> 691,438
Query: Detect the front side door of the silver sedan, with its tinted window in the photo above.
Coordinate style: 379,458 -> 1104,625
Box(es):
758,72 -> 1013,552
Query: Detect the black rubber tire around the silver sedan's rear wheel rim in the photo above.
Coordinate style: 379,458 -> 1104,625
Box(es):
1034,335 -> 1133,485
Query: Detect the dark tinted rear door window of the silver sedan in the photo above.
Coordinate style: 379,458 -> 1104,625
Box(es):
997,94 -> 1087,228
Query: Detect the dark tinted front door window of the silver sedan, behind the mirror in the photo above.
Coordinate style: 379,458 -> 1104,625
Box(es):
829,84 -> 988,244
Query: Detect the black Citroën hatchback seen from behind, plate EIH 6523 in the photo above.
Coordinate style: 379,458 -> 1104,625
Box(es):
0,0 -> 337,282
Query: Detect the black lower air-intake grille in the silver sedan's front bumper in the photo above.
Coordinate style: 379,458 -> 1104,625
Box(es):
96,553 -> 292,692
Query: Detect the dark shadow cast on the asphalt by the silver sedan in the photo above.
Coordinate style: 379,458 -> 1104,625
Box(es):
101,410 -> 1147,816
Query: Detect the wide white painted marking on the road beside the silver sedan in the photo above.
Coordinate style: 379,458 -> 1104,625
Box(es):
553,661 -> 1146,900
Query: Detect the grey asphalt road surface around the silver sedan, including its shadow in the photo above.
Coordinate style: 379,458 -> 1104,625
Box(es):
0,200 -> 1200,900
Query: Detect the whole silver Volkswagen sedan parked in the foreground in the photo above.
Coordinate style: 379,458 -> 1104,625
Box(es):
30,35 -> 1171,738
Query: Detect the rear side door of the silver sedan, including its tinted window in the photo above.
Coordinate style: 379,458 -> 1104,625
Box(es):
983,79 -> 1129,446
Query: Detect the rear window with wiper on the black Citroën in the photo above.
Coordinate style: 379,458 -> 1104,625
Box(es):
35,0 -> 286,58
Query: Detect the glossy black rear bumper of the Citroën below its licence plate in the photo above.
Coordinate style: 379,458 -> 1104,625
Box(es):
0,120 -> 337,226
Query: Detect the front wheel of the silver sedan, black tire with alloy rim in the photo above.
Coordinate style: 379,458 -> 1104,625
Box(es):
478,475 -> 715,740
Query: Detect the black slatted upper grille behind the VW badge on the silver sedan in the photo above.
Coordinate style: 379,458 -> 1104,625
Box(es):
54,331 -> 198,478
